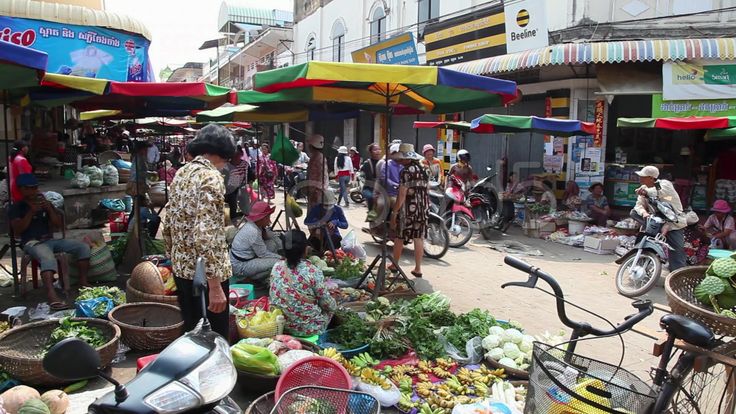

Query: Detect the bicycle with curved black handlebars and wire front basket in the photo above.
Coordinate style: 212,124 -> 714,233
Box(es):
501,256 -> 733,414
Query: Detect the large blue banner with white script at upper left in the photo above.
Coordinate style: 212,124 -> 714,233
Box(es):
0,16 -> 155,82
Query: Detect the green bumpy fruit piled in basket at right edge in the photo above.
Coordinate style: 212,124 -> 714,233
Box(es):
693,253 -> 736,318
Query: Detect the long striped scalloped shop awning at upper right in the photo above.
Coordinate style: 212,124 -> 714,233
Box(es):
446,37 -> 736,75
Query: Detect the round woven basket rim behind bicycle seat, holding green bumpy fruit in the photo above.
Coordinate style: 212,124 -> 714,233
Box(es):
664,266 -> 736,336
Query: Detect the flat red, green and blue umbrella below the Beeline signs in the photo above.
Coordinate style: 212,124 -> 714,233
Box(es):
414,114 -> 595,137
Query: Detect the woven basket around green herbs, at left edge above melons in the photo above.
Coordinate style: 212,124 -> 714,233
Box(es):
0,318 -> 120,387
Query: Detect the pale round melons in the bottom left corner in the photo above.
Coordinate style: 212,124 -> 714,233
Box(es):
0,385 -> 69,414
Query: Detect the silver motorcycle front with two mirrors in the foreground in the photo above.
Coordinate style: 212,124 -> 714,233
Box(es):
43,258 -> 242,414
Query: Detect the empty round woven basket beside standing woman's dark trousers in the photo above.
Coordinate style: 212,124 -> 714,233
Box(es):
107,302 -> 184,351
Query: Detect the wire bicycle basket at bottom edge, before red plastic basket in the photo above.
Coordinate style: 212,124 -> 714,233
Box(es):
271,385 -> 381,414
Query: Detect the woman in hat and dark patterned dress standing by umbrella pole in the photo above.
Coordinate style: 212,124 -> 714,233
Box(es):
389,144 -> 429,277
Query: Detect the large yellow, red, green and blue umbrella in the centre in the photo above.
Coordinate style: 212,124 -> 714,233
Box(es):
253,61 -> 517,114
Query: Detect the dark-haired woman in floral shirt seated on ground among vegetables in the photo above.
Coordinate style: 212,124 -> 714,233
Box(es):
269,230 -> 337,336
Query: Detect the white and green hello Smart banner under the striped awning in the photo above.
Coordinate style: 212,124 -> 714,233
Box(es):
662,60 -> 736,101
